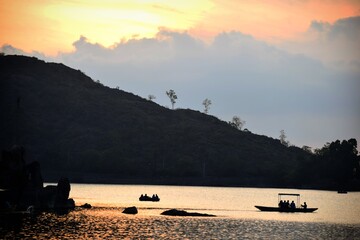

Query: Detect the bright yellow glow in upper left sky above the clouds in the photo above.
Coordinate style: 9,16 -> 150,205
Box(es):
0,0 -> 212,54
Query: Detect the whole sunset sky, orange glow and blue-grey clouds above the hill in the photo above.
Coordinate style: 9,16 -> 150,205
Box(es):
0,0 -> 360,150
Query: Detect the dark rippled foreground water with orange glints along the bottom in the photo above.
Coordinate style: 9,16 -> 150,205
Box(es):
0,208 -> 360,239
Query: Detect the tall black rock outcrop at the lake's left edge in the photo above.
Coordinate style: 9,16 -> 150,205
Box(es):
0,146 -> 75,210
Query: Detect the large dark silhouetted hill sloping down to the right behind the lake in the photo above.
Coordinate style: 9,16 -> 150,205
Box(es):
0,56 -> 358,187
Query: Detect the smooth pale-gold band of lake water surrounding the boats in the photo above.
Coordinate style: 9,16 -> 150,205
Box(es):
71,184 -> 360,224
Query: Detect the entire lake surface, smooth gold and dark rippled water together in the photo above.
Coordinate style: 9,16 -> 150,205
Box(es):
0,184 -> 360,239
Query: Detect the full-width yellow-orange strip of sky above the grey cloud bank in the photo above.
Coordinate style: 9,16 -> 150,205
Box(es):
0,0 -> 360,55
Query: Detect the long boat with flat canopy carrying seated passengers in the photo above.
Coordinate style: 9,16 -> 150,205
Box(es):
255,193 -> 318,213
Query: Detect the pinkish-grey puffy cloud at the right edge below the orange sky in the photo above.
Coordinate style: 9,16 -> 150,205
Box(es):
281,16 -> 360,73
